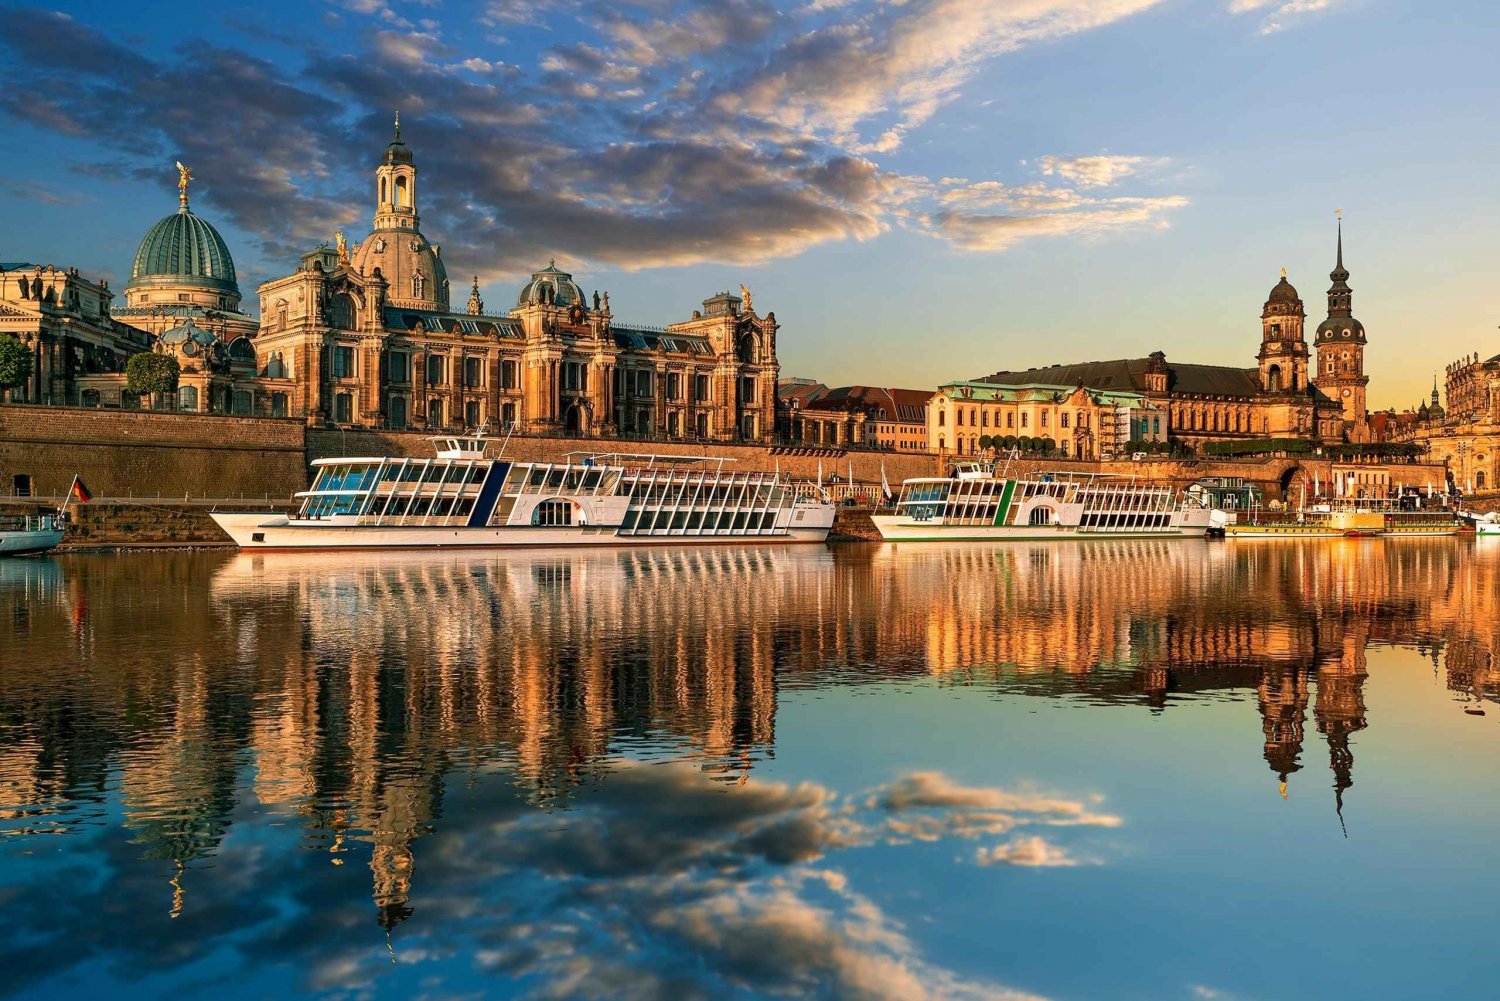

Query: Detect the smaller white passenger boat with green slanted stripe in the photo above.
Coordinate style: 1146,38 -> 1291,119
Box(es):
872,464 -> 1226,542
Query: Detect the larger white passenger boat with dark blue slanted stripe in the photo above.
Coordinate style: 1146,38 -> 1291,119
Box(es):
213,437 -> 834,549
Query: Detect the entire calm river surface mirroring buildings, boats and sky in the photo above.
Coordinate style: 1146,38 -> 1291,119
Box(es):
0,539 -> 1500,1001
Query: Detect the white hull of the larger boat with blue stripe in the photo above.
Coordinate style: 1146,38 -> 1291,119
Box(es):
212,512 -> 833,551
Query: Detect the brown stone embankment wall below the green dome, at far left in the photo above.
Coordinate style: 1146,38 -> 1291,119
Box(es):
0,405 -> 306,498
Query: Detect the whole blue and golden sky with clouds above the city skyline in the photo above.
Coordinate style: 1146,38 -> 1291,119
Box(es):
0,0 -> 1500,407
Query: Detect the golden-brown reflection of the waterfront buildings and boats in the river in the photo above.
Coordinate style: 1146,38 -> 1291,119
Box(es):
0,540 -> 1500,929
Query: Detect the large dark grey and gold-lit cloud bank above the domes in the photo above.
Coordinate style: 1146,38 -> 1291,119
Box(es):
0,0 -> 1194,288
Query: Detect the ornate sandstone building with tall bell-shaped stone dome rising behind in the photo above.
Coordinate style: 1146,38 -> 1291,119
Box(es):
255,120 -> 779,441
